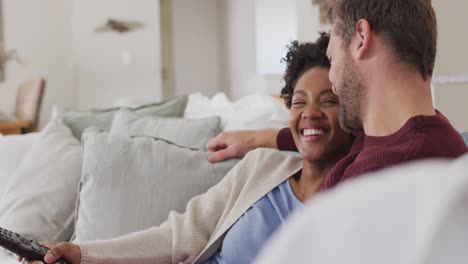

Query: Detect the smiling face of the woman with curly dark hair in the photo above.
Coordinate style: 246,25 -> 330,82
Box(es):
289,67 -> 352,163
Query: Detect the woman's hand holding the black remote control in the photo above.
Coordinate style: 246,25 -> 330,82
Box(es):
18,242 -> 81,264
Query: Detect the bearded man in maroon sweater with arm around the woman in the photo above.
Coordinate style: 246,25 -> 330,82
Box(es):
208,0 -> 467,189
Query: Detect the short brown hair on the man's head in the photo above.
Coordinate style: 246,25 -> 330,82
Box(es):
329,0 -> 437,80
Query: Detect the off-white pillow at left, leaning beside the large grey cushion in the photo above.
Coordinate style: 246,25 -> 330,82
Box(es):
0,121 -> 83,241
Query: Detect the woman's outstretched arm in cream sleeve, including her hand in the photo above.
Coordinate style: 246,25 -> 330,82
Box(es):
22,151 -> 289,264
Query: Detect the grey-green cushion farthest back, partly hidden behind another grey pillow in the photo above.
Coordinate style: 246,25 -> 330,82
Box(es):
62,96 -> 188,139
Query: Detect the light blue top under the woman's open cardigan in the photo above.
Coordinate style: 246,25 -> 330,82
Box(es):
205,180 -> 302,264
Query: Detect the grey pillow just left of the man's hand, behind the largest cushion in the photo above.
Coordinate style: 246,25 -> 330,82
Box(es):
110,109 -> 221,149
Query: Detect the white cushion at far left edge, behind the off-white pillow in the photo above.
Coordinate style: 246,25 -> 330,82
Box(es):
0,133 -> 38,201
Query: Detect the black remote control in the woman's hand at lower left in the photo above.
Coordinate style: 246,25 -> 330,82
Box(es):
0,228 -> 69,264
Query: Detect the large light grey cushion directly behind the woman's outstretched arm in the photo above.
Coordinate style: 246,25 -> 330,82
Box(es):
74,129 -> 241,242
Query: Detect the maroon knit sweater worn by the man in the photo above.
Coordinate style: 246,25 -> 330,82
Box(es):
277,112 -> 467,190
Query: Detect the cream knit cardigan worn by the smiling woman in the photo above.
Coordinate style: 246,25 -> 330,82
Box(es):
79,149 -> 302,264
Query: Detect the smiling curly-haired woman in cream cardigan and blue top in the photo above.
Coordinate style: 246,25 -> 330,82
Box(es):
20,33 -> 352,264
